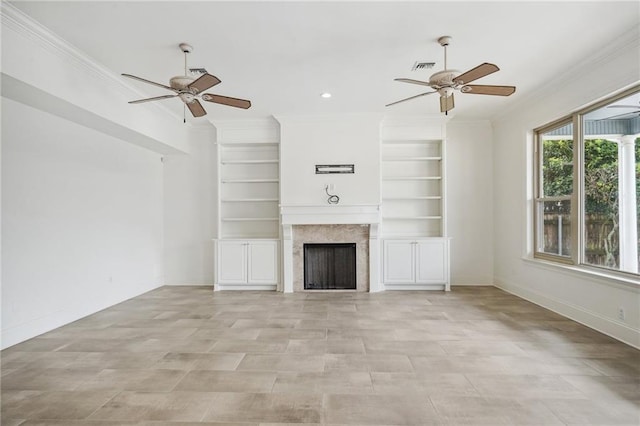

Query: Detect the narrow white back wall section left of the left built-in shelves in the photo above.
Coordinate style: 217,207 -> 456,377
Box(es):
163,124 -> 217,285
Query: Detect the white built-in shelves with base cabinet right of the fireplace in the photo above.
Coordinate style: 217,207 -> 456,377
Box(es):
380,122 -> 450,291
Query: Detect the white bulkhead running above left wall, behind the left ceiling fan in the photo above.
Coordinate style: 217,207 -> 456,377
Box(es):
0,2 -> 187,153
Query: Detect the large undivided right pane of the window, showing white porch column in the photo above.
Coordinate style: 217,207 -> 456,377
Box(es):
582,92 -> 640,273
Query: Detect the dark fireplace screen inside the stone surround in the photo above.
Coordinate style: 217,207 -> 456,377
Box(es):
304,243 -> 356,290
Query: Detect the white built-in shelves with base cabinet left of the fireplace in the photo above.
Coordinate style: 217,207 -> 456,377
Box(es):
214,120 -> 281,290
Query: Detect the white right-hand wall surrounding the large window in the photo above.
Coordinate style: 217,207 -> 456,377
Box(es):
493,28 -> 640,347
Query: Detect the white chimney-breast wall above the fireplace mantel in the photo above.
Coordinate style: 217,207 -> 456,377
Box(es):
276,114 -> 382,206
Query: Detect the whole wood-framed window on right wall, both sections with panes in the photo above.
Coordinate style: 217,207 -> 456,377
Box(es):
534,87 -> 640,274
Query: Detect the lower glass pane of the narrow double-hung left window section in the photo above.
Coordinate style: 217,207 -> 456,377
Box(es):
537,200 -> 571,257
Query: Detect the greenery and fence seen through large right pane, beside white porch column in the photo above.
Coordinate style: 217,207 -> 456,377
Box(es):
584,139 -> 620,269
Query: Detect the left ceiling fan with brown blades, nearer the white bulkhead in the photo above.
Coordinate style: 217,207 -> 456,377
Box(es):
122,43 -> 251,121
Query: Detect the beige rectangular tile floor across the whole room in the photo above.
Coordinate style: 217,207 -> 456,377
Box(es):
1,287 -> 640,426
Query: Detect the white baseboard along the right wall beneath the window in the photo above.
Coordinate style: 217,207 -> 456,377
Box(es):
494,278 -> 640,349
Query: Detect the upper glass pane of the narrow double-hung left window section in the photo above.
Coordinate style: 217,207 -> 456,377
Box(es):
540,128 -> 573,197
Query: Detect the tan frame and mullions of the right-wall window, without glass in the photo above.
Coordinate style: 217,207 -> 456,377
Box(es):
532,85 -> 640,284
